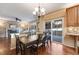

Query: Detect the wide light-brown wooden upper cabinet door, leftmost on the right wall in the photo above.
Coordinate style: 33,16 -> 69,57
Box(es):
67,7 -> 77,27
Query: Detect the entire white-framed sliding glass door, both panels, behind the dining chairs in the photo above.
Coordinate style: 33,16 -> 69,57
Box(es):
45,18 -> 64,43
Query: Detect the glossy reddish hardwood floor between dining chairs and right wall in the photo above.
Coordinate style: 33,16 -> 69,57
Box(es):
12,43 -> 75,55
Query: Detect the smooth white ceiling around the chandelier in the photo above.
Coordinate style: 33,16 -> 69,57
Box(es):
0,3 -> 71,21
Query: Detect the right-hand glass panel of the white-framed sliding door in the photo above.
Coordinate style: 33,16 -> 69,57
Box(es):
51,18 -> 64,43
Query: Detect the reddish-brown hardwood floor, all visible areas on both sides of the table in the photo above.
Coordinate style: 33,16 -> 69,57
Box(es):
0,40 -> 75,55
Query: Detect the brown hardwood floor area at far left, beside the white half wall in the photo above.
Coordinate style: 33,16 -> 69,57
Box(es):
0,39 -> 10,55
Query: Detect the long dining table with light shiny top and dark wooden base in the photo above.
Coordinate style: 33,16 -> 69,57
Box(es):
20,35 -> 38,54
